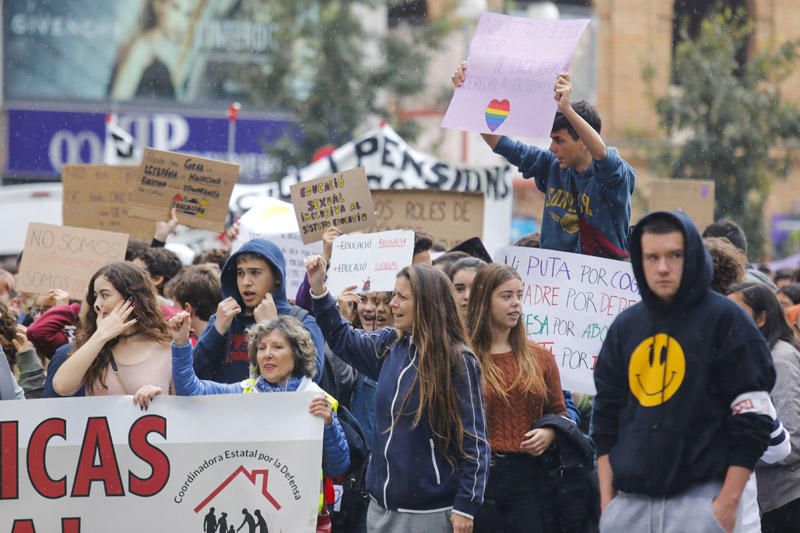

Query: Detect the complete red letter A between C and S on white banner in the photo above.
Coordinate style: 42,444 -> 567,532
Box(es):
72,417 -> 125,498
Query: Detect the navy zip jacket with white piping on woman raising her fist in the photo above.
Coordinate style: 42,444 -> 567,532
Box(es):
312,288 -> 490,517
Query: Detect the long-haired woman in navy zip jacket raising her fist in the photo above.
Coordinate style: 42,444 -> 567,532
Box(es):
306,256 -> 489,533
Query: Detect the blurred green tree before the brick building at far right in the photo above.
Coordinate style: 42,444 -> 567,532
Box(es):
656,9 -> 800,258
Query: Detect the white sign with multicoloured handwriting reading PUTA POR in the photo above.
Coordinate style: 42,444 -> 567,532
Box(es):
494,246 -> 641,394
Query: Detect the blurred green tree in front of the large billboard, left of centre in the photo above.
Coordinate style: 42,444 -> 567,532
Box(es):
234,0 -> 449,178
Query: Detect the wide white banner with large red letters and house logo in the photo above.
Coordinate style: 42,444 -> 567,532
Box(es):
0,392 -> 323,533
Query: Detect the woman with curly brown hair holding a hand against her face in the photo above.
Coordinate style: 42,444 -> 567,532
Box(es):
53,262 -> 172,406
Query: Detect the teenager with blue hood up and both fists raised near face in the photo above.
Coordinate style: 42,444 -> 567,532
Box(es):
192,239 -> 325,383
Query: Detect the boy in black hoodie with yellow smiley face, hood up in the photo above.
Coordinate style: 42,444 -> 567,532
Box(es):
591,212 -> 775,533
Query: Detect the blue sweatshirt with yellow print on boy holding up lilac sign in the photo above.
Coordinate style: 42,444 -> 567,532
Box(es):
494,137 -> 636,255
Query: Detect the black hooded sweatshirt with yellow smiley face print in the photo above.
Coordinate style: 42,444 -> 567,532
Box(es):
591,212 -> 775,497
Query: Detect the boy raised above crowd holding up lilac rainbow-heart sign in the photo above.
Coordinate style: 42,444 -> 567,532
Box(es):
452,62 -> 636,259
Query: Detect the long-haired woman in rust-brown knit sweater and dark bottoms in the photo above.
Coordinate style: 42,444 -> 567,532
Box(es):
467,263 -> 566,533
